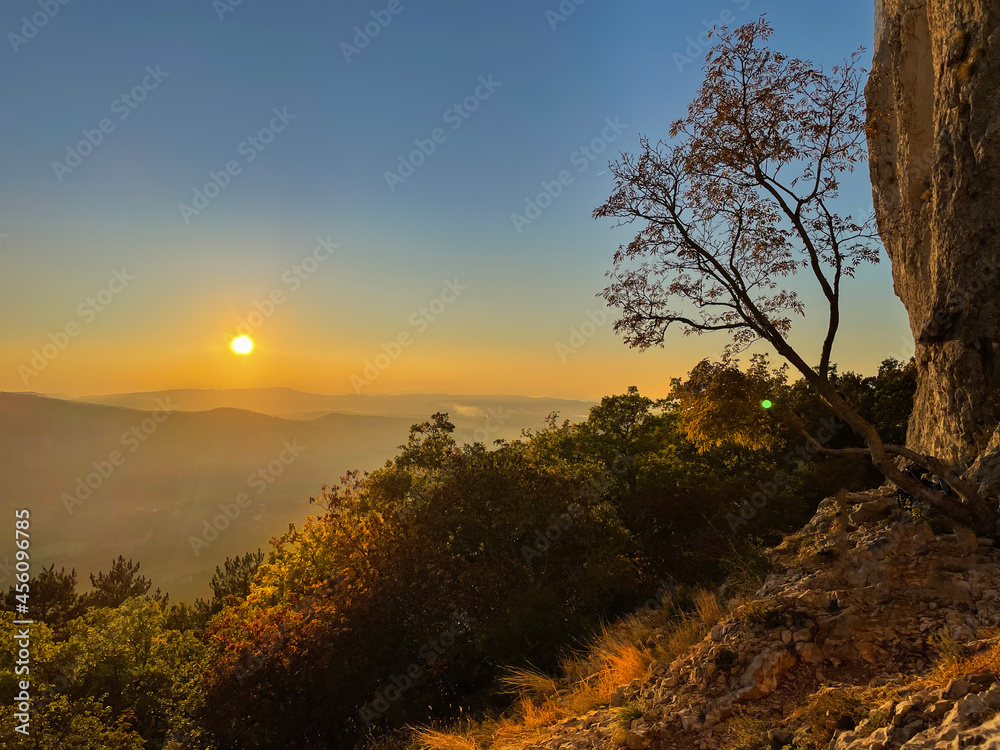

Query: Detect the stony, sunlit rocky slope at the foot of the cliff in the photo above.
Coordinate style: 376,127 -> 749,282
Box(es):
512,489 -> 1000,750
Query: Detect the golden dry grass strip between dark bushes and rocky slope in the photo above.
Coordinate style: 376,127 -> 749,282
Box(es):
414,591 -> 725,750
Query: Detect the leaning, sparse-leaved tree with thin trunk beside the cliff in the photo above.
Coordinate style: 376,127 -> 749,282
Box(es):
594,19 -> 997,536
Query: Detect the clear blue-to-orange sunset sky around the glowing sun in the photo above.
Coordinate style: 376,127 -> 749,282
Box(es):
0,0 -> 912,399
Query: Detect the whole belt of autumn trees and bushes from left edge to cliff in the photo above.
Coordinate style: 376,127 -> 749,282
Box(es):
0,370 -> 913,750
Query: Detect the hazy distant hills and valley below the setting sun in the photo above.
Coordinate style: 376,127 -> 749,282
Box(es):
0,388 -> 591,599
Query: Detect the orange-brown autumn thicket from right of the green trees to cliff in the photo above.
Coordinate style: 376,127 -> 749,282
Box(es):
206,374 -> 912,750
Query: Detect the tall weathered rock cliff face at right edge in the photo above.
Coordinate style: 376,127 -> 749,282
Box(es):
867,0 -> 1000,462
